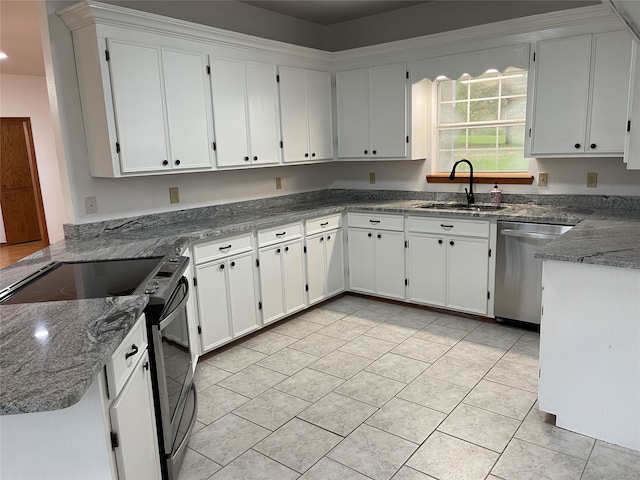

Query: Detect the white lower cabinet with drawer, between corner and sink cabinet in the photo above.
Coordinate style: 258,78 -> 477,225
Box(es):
347,213 -> 405,300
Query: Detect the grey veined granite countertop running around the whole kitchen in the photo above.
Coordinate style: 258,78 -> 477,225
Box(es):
0,195 -> 640,415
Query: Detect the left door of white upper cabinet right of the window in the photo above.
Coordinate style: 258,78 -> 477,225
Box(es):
530,35 -> 591,156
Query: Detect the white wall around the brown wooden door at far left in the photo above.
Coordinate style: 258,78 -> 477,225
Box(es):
0,75 -> 67,243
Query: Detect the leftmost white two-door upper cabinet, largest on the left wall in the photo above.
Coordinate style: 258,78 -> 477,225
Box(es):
102,38 -> 213,176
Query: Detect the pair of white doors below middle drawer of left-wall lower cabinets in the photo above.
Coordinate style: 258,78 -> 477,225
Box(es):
259,238 -> 306,325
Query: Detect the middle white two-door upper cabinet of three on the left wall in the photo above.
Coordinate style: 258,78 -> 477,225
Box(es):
210,58 -> 280,167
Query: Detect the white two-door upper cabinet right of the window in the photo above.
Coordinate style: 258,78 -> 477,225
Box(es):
525,32 -> 632,157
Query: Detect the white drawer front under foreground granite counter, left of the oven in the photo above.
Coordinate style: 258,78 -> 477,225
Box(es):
107,314 -> 147,398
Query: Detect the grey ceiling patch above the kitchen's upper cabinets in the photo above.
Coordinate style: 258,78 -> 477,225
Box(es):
239,0 -> 429,25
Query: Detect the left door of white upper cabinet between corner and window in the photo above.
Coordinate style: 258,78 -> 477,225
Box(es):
336,68 -> 370,158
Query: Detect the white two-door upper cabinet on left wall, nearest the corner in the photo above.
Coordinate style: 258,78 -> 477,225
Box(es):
279,67 -> 333,162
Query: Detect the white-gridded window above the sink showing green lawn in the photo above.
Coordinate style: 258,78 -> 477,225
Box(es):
437,68 -> 529,172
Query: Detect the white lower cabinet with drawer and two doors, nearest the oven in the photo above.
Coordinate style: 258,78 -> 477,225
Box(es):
194,235 -> 261,353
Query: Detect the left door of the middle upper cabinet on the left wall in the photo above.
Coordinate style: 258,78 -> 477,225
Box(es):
209,58 -> 250,167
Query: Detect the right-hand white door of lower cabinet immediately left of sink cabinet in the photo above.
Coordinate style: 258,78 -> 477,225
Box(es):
375,231 -> 406,300
